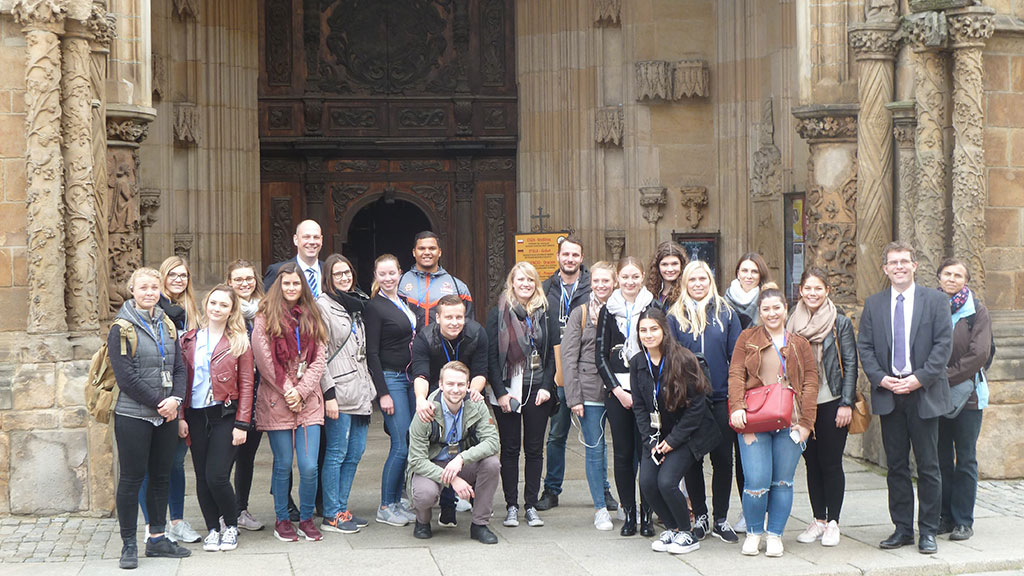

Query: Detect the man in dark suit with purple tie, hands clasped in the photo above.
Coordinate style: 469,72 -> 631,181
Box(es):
857,242 -> 952,553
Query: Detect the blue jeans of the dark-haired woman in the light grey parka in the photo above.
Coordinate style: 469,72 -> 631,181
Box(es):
321,413 -> 370,520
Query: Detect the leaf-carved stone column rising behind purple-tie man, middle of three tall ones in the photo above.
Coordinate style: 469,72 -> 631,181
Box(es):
906,12 -> 949,286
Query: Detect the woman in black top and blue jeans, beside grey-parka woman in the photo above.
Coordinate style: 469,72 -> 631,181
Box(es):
365,254 -> 416,526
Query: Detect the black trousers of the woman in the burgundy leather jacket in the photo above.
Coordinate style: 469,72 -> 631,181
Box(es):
185,406 -> 239,530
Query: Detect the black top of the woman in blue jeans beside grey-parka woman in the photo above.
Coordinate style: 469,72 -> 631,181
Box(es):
364,294 -> 413,398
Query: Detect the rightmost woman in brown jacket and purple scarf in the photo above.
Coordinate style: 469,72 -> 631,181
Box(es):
936,258 -> 992,540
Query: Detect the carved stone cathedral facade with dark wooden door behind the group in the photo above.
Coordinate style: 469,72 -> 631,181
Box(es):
0,0 -> 1024,515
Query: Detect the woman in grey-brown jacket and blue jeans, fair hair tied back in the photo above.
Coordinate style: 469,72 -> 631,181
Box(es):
562,261 -> 615,530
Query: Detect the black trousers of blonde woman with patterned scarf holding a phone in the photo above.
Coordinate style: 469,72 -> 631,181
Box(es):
491,390 -> 555,508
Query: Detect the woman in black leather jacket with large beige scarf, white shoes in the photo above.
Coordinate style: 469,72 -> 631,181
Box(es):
786,268 -> 857,546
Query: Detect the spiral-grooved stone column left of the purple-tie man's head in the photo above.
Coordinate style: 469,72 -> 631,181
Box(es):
850,17 -> 897,305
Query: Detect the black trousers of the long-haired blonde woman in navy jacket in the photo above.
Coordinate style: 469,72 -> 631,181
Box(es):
686,400 -> 739,522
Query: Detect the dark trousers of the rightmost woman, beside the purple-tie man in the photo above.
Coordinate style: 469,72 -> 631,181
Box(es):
939,408 -> 982,527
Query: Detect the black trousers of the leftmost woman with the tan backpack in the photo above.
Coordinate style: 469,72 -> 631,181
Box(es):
114,414 -> 178,540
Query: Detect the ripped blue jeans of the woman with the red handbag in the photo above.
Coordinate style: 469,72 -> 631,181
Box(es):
739,428 -> 804,536
